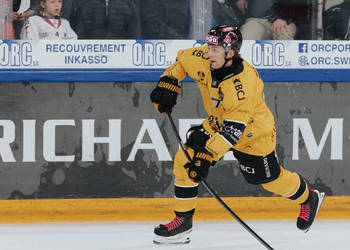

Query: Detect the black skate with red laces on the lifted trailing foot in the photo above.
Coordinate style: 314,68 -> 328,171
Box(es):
297,190 -> 325,233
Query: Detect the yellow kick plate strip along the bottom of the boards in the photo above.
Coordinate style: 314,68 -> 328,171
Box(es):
0,196 -> 350,223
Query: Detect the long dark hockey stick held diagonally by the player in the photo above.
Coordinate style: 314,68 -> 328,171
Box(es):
167,112 -> 273,250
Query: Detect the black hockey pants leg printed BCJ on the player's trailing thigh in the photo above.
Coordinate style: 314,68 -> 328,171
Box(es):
233,150 -> 281,185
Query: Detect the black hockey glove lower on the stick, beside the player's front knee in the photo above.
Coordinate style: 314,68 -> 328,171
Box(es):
185,149 -> 213,182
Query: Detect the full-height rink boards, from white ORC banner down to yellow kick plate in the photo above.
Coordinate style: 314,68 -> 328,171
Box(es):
0,40 -> 350,222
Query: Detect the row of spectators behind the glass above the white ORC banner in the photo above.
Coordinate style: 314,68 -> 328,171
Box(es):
0,0 -> 350,40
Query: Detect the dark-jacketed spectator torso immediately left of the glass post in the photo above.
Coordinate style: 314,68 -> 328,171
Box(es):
138,0 -> 191,39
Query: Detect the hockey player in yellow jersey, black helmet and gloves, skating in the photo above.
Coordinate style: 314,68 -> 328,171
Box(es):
150,25 -> 324,243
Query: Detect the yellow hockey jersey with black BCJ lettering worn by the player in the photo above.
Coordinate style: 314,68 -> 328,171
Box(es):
162,46 -> 276,160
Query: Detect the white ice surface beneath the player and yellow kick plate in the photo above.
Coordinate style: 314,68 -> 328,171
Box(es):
0,220 -> 350,250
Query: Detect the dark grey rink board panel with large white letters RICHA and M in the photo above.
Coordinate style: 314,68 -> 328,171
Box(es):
0,82 -> 350,200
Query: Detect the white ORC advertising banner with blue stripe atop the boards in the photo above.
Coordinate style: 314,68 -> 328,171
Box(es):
0,40 -> 350,82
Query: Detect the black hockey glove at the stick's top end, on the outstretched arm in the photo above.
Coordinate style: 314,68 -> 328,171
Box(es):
150,76 -> 181,113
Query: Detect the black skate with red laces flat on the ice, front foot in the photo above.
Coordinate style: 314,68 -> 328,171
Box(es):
153,216 -> 192,244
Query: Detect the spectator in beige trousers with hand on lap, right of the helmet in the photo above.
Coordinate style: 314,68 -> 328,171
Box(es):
237,0 -> 310,40
